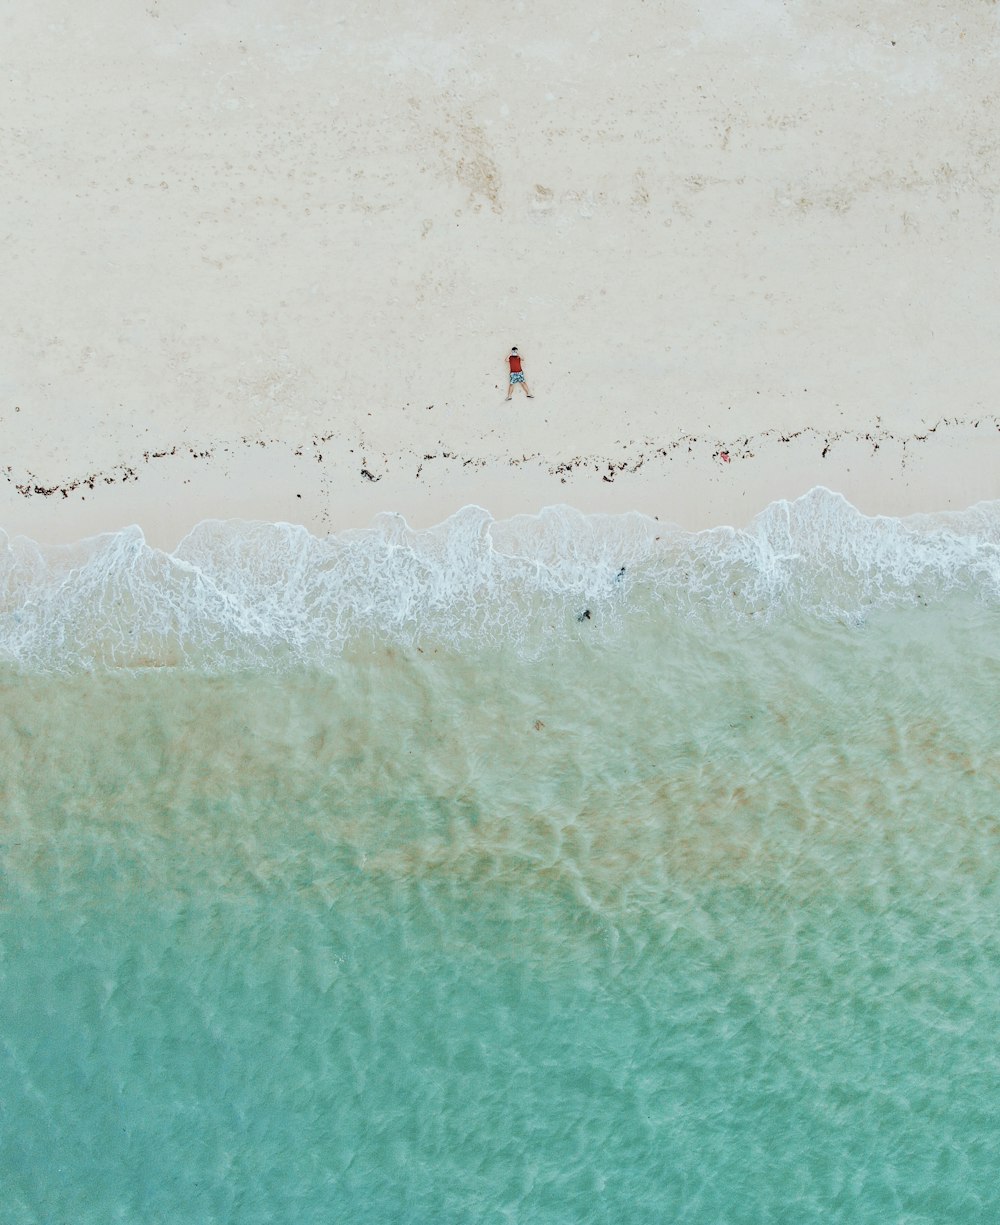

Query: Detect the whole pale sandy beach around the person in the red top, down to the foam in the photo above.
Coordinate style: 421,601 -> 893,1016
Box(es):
0,0 -> 1000,544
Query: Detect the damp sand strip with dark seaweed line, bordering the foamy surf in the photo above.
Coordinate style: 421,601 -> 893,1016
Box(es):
0,417 -> 1000,549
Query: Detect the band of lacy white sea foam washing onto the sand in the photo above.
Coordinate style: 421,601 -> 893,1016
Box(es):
0,489 -> 1000,671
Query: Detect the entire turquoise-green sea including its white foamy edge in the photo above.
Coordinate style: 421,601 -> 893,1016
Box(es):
0,490 -> 1000,1225
